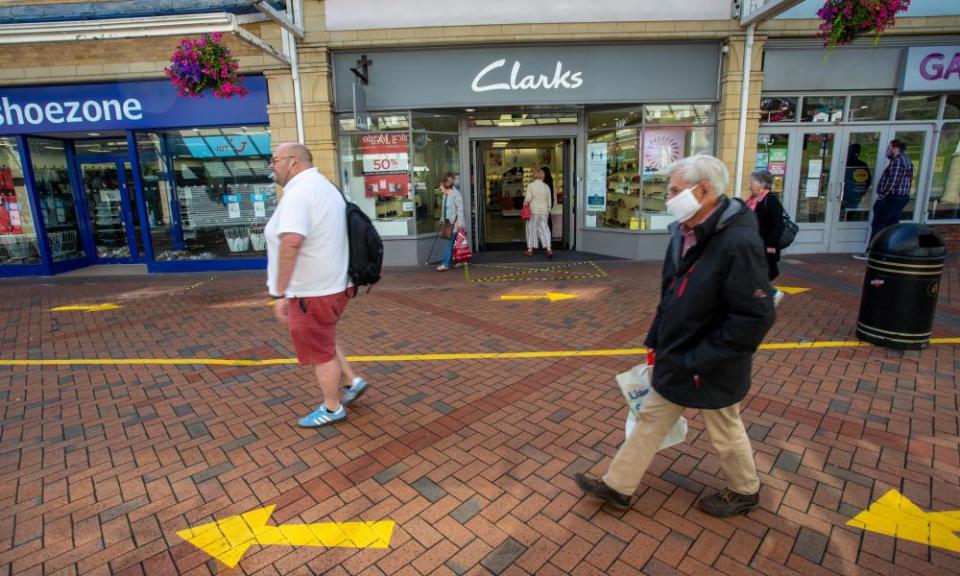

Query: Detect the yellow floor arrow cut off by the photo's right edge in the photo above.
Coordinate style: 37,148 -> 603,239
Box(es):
847,490 -> 960,552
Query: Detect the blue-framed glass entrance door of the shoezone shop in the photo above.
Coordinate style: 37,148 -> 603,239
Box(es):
78,158 -> 142,264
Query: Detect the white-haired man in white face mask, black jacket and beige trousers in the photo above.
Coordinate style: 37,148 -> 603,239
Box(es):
575,155 -> 774,517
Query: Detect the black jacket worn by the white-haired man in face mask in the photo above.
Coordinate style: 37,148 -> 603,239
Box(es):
645,198 -> 774,409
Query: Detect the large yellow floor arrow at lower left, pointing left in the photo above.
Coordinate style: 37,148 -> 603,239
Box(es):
177,506 -> 395,568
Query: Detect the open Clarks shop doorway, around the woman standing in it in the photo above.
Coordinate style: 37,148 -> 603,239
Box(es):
471,138 -> 574,251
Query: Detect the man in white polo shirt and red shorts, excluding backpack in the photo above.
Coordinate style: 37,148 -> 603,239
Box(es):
264,142 -> 367,428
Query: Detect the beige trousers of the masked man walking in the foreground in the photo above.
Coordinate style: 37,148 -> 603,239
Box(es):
603,389 -> 760,495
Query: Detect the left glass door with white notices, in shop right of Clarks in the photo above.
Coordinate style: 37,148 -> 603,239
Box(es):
787,127 -> 840,252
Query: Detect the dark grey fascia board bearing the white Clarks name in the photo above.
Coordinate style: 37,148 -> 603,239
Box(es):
333,42 -> 722,112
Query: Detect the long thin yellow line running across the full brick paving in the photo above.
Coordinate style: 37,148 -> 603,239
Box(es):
0,338 -> 960,366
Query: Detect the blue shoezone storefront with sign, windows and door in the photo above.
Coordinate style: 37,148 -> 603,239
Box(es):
0,76 -> 276,276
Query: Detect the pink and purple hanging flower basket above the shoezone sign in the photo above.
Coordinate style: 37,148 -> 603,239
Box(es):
164,32 -> 248,98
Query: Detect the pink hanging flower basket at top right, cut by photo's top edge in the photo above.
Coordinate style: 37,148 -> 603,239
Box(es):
817,0 -> 910,50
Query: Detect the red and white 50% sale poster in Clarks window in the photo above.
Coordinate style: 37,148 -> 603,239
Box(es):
360,132 -> 410,198
